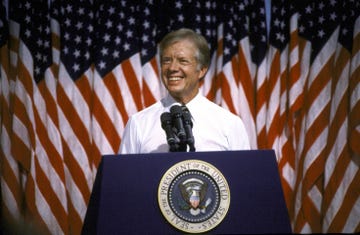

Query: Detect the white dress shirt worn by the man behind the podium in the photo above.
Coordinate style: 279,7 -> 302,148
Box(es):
119,93 -> 250,154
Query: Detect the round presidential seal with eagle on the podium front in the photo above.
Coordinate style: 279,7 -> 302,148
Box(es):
158,160 -> 230,233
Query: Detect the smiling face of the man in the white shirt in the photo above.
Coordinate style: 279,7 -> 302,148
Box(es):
161,40 -> 207,103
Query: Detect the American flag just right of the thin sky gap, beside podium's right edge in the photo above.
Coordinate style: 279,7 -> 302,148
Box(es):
266,0 -> 298,221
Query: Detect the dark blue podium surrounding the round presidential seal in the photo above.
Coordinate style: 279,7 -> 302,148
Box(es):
82,150 -> 292,234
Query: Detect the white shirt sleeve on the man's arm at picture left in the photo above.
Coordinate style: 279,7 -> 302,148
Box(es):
119,117 -> 139,154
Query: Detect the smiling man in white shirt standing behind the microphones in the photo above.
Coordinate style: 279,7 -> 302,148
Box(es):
119,29 -> 250,154
